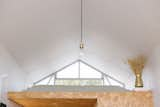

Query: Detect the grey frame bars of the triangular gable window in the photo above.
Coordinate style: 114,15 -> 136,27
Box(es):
33,60 -> 125,88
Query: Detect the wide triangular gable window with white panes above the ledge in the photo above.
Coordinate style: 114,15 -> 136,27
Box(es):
34,60 -> 124,86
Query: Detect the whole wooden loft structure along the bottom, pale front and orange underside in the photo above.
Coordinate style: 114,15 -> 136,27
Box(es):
8,91 -> 153,107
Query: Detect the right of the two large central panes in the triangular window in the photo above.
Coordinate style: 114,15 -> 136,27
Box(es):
80,62 -> 102,78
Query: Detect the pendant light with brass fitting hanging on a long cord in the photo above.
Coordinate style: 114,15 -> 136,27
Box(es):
79,0 -> 84,56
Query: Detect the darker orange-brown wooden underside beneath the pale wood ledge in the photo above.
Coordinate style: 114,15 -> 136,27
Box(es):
10,98 -> 97,107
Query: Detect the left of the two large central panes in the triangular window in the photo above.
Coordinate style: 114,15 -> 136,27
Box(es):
57,62 -> 79,78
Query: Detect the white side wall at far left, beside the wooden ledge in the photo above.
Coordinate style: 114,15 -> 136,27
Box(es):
0,45 -> 26,107
